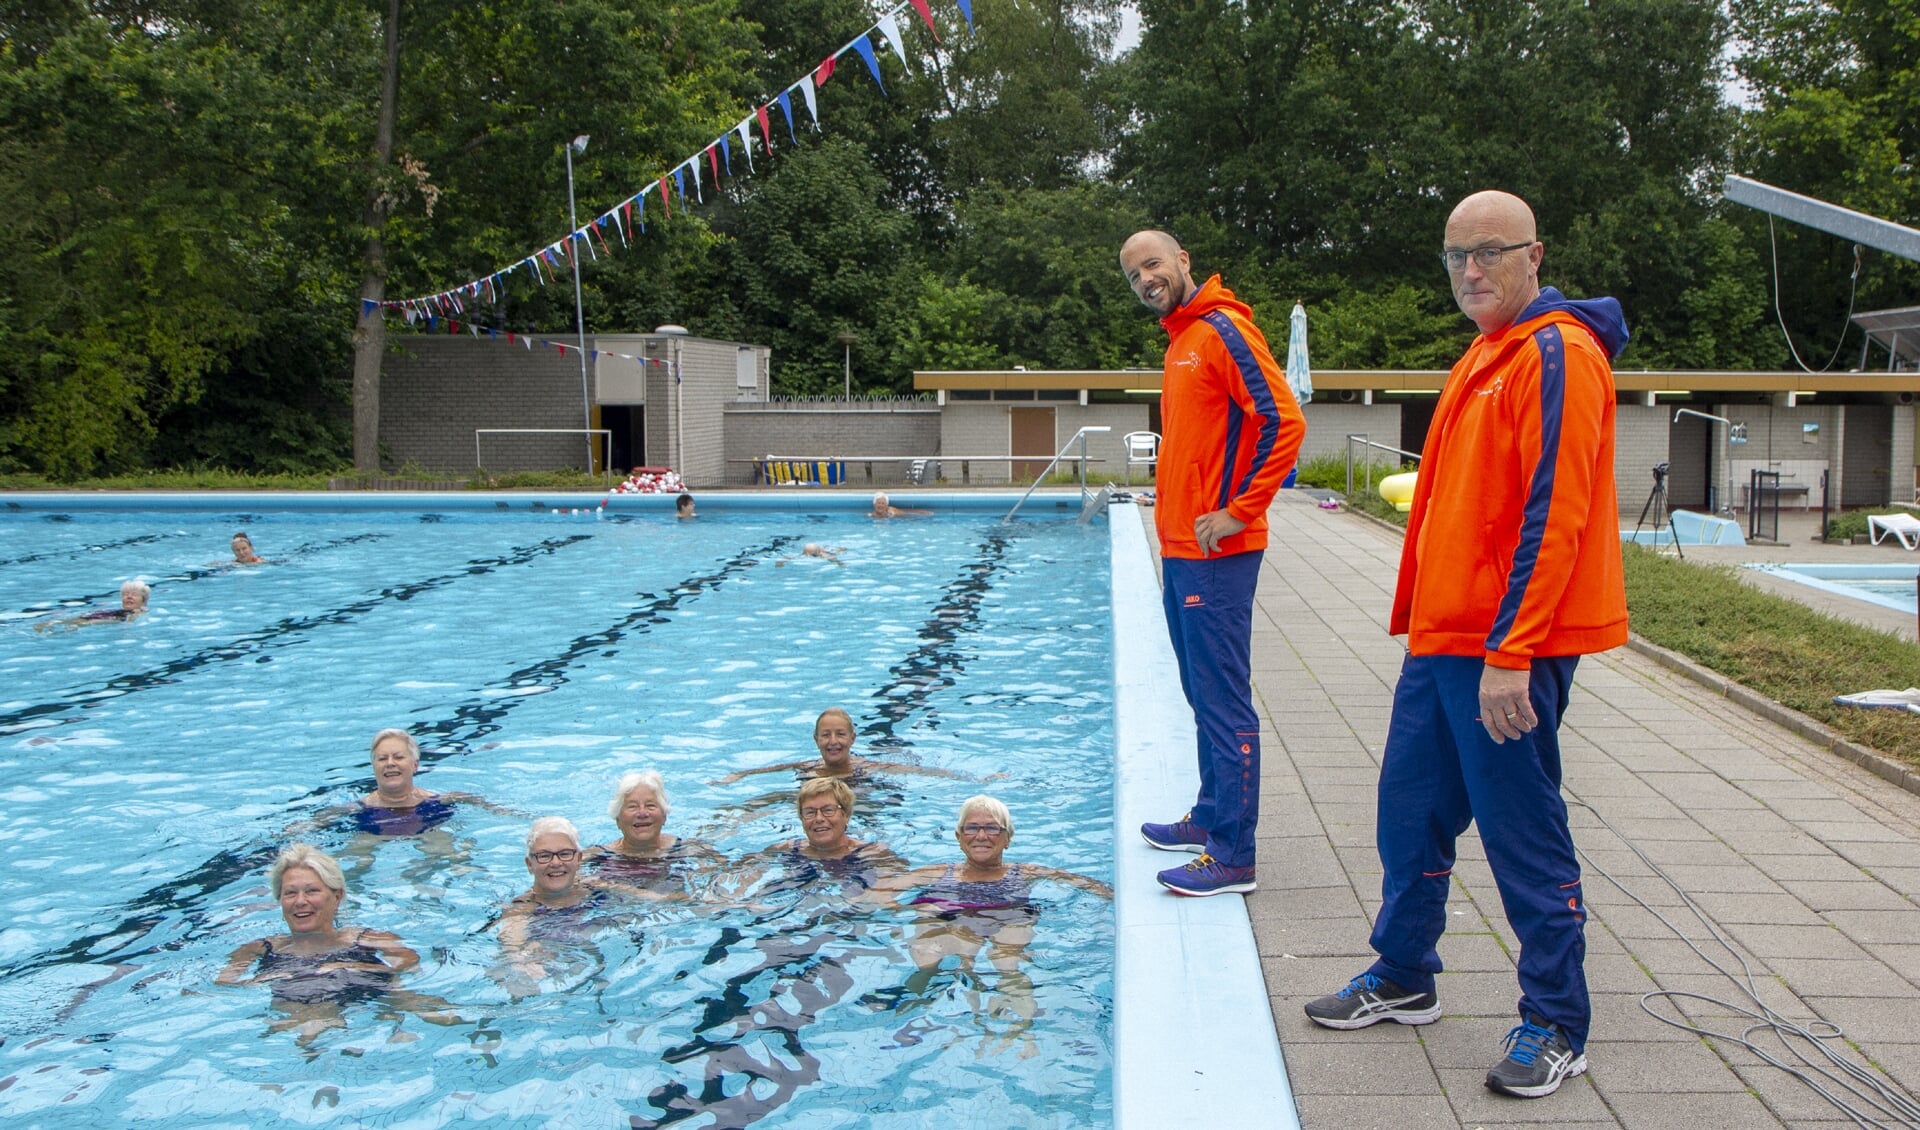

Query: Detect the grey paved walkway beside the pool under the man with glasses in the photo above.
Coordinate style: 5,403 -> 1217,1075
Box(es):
1248,491 -> 1920,1130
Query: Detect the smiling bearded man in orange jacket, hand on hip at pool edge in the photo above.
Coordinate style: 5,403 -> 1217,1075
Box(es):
1119,232 -> 1306,894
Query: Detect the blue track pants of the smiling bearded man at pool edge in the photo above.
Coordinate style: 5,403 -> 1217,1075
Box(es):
1160,551 -> 1265,867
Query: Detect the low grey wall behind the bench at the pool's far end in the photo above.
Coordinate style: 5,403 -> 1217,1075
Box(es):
724,397 -> 944,485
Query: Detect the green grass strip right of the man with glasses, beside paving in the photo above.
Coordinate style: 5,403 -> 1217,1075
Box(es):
1622,545 -> 1920,764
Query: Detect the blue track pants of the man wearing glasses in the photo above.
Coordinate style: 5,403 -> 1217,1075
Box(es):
1371,656 -> 1592,1051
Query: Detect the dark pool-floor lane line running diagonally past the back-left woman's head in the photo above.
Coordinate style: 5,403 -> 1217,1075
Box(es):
0,533 -> 799,978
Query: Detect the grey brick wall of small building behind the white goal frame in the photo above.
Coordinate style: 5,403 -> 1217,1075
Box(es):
380,336 -> 586,472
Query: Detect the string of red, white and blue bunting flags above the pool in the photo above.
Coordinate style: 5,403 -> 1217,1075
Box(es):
361,0 -> 973,316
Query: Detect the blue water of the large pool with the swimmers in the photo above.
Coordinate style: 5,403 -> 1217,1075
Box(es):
0,501 -> 1112,1126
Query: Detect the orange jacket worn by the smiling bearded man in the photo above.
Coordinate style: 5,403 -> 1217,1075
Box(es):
1154,274 -> 1308,558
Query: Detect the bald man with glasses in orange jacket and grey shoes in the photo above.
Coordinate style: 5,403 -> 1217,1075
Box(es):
1306,192 -> 1626,1099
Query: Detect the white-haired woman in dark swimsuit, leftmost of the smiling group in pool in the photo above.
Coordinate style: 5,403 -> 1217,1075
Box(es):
213,844 -> 463,1046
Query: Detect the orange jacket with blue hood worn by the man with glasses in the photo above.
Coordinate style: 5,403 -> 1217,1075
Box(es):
1388,288 -> 1626,670
